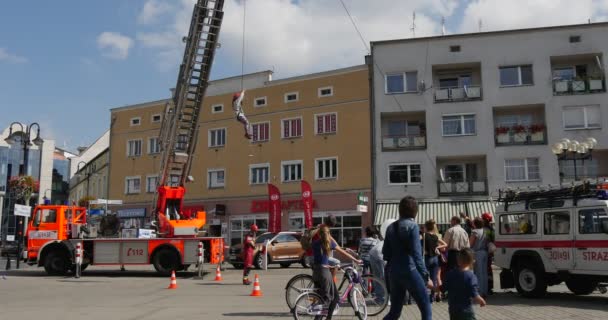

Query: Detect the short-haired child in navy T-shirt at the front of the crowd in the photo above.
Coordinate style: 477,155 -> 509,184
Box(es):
444,248 -> 486,320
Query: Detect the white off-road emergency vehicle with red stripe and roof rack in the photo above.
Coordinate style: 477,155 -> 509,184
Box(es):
494,182 -> 608,297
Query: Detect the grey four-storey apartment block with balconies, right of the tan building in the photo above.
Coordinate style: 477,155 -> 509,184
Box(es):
368,23 -> 608,228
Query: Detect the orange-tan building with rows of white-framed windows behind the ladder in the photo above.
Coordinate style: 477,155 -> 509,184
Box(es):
109,65 -> 371,246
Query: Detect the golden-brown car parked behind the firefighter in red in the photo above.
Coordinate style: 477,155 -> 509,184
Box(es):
228,232 -> 308,269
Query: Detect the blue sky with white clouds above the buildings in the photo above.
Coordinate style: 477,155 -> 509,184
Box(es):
0,0 -> 608,150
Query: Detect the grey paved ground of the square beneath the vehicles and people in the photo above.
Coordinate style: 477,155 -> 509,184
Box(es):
0,258 -> 608,320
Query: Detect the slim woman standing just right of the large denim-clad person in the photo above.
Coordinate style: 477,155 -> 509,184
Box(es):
422,219 -> 447,303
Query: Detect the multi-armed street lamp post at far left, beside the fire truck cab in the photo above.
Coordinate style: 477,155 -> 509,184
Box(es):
4,122 -> 44,269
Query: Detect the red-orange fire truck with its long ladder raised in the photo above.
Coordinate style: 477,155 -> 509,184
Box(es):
24,0 -> 224,275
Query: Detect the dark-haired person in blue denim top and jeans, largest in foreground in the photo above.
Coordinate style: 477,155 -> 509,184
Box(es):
382,196 -> 433,320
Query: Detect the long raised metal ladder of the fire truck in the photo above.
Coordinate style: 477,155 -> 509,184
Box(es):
155,0 -> 224,192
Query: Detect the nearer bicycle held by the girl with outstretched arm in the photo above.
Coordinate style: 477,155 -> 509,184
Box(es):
292,263 -> 368,320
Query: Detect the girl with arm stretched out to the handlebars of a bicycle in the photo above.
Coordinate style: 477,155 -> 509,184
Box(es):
312,225 -> 361,319
